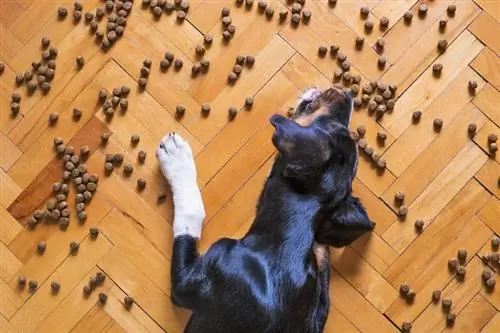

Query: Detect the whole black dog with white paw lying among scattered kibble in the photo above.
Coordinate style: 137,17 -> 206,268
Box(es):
157,88 -> 374,333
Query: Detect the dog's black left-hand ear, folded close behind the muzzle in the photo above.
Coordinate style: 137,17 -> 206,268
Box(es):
270,115 -> 332,167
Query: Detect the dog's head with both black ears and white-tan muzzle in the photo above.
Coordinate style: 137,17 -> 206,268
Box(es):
271,88 -> 374,247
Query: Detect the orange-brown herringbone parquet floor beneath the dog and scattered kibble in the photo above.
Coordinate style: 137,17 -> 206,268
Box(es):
0,0 -> 500,333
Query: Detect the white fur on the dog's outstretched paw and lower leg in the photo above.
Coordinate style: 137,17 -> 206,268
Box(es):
156,133 -> 205,239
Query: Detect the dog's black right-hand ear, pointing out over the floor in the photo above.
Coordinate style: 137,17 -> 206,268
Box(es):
316,195 -> 375,247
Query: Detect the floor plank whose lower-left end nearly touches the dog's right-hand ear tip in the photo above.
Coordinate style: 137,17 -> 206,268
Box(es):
382,142 -> 487,253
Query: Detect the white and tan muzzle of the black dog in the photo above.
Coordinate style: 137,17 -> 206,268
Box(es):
291,88 -> 352,126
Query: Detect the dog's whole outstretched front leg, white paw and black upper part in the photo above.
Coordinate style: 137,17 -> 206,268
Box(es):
156,133 -> 207,309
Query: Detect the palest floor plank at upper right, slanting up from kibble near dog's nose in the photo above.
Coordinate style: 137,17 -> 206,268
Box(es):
380,29 -> 484,137
